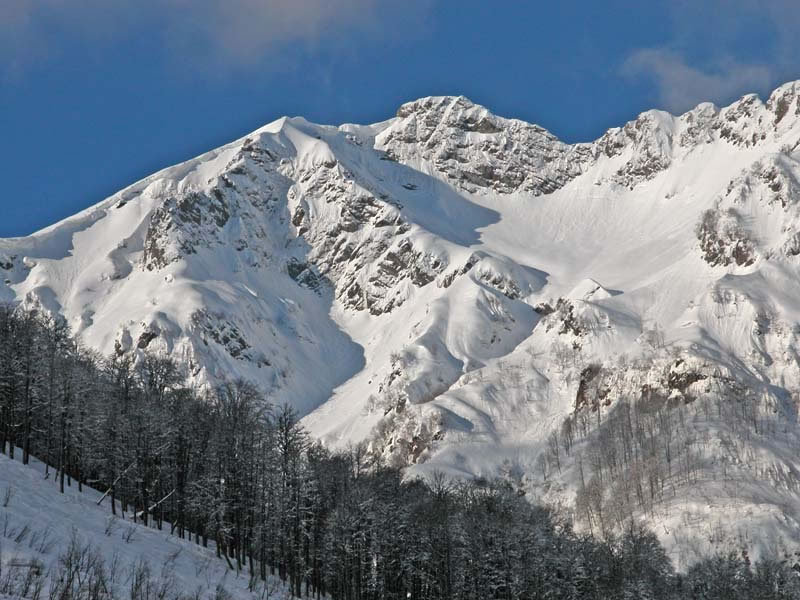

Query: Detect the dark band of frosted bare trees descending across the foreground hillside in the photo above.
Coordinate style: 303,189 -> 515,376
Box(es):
0,305 -> 800,600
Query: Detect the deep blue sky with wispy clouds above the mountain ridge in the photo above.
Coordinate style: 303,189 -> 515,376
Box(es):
0,0 -> 800,237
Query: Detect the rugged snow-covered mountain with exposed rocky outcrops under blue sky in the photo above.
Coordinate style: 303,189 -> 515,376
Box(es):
7,82 -> 800,564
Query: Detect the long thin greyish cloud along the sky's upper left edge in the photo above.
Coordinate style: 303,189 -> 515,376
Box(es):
0,0 -> 428,72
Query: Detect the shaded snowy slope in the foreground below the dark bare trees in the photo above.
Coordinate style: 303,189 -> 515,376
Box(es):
0,455 -> 291,599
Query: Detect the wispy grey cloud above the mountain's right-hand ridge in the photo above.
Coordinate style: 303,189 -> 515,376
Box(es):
621,0 -> 800,112
